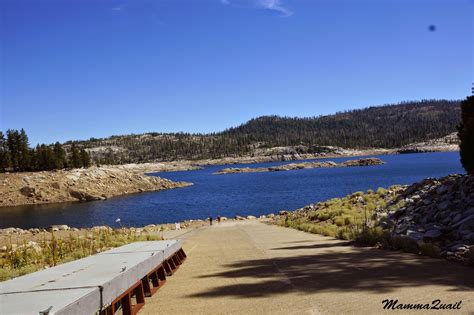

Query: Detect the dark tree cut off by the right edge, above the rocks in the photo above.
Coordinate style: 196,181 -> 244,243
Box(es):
458,96 -> 474,175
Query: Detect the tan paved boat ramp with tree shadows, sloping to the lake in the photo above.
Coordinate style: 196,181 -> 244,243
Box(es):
140,222 -> 474,314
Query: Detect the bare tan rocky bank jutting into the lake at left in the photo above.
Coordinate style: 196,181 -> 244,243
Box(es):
0,166 -> 190,207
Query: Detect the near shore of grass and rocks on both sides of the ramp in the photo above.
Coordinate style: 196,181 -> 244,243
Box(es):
0,174 -> 474,274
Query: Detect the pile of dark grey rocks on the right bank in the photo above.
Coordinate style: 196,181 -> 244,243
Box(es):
378,175 -> 474,259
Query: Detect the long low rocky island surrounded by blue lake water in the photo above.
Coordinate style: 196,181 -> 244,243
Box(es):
213,158 -> 385,175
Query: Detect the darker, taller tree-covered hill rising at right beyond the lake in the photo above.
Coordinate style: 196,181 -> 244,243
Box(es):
223,100 -> 460,148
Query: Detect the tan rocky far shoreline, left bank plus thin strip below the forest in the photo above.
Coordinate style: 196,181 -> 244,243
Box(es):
0,146 -> 460,211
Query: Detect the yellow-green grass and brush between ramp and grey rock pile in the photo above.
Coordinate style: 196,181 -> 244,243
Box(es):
280,186 -> 456,264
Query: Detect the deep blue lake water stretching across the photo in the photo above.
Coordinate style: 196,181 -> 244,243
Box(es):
0,152 -> 464,228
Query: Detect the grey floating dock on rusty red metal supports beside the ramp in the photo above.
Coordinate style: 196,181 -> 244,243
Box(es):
0,240 -> 186,314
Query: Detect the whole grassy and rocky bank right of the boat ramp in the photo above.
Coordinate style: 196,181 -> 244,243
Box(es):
274,174 -> 474,265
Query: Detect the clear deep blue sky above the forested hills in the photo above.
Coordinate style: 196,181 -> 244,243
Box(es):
0,0 -> 474,144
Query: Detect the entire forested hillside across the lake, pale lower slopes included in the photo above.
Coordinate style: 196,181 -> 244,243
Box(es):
66,100 -> 460,164
